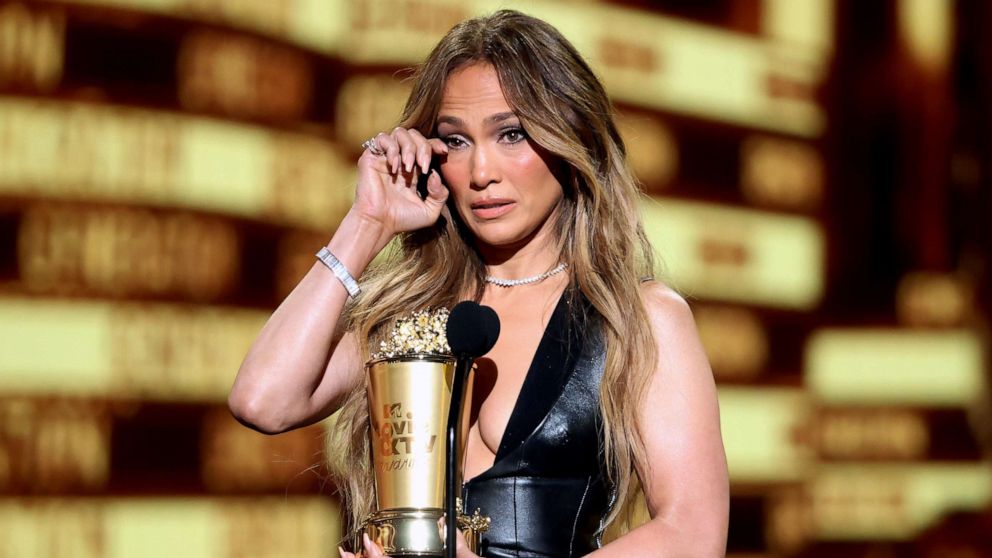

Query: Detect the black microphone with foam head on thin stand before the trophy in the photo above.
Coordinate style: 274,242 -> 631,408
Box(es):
444,300 -> 499,558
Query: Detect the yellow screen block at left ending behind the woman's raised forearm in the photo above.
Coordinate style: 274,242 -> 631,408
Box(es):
0,297 -> 268,402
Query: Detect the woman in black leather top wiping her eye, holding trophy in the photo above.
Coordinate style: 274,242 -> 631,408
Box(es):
230,11 -> 728,558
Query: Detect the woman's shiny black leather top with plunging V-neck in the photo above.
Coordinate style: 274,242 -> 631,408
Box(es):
462,294 -> 611,558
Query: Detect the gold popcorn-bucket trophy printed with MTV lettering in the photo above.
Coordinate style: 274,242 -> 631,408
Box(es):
352,302 -> 499,558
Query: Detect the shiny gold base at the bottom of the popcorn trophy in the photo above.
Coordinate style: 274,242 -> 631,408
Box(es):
351,508 -> 489,558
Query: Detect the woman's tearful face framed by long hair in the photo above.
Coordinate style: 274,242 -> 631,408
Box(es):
437,63 -> 563,254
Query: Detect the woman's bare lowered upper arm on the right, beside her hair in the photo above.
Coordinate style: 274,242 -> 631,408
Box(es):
637,282 -> 729,548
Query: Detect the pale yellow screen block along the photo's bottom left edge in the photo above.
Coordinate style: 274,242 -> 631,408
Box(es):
0,497 -> 341,558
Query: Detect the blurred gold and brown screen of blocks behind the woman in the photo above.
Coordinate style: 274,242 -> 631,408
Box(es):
0,0 -> 992,558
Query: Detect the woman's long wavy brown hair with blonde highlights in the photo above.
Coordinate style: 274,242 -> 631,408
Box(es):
330,10 -> 657,532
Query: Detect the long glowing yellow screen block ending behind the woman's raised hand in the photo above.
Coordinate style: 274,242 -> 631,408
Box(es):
0,96 -> 355,230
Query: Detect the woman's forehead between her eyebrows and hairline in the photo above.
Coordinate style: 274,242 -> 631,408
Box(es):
440,63 -> 510,118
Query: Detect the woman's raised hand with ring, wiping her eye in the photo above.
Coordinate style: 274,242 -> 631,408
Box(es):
352,127 -> 448,238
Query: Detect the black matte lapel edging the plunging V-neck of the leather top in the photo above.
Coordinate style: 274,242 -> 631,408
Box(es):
465,289 -> 581,484
